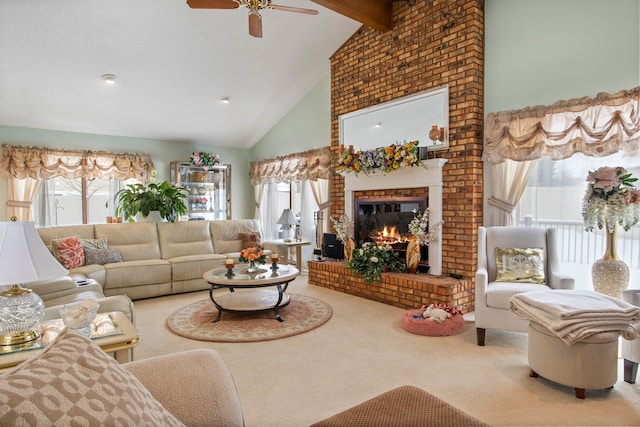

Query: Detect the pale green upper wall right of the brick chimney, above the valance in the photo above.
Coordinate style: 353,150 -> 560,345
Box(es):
485,0 -> 640,112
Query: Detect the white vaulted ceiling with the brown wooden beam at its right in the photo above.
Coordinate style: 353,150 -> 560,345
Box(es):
0,0 -> 391,148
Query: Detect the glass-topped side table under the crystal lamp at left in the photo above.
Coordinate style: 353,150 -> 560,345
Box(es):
0,311 -> 140,370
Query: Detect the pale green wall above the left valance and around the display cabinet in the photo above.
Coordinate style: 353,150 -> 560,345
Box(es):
0,126 -> 253,221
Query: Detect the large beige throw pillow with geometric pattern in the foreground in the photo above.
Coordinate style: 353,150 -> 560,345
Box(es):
0,329 -> 184,426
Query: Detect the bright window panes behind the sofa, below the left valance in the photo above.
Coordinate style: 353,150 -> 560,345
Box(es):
32,177 -> 138,226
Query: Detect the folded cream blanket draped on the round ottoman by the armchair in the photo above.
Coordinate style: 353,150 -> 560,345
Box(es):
509,289 -> 640,345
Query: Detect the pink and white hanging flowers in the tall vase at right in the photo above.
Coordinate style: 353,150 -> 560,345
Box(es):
582,166 -> 640,232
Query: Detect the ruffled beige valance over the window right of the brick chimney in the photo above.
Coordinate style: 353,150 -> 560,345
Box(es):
483,87 -> 640,164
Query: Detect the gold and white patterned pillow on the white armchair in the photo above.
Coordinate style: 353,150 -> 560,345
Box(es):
495,248 -> 545,283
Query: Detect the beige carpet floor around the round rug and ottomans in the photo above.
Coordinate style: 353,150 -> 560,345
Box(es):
134,276 -> 640,427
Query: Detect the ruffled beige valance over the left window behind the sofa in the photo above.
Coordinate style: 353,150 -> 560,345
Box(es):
0,144 -> 154,181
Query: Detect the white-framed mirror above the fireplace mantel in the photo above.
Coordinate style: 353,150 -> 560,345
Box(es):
338,85 -> 449,151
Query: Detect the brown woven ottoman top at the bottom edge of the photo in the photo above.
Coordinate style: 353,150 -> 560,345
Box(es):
311,385 -> 489,427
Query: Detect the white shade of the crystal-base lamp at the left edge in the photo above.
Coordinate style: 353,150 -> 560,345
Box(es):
0,222 -> 69,285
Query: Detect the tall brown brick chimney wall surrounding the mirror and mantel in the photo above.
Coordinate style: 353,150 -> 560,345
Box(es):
330,0 -> 484,279
